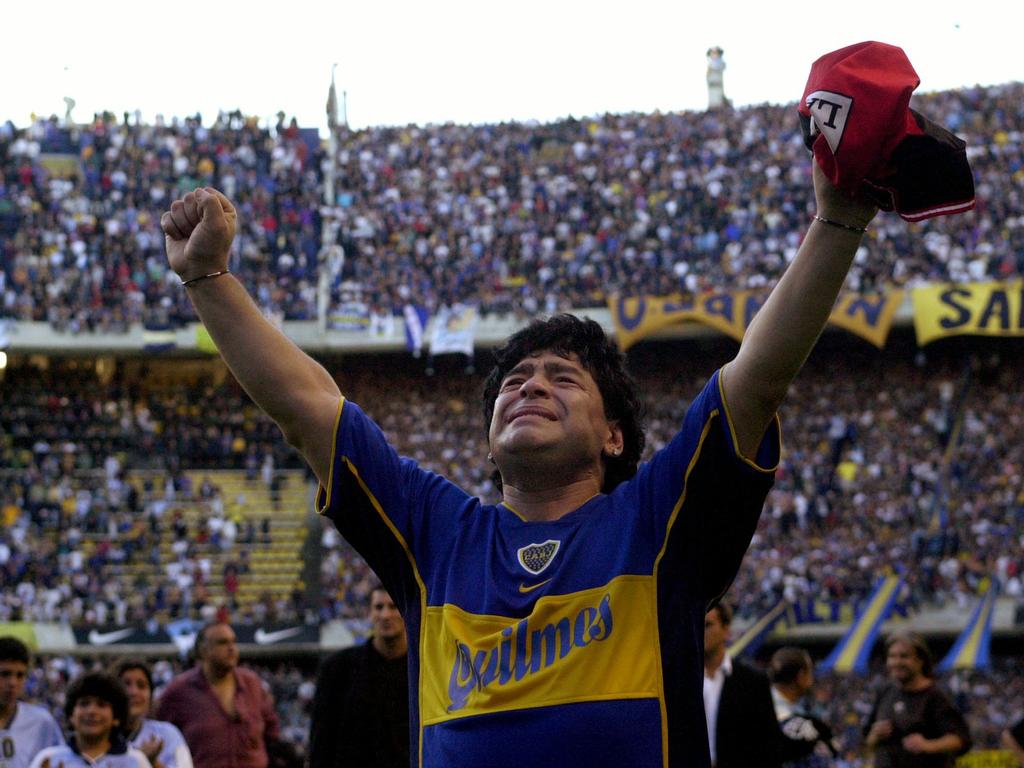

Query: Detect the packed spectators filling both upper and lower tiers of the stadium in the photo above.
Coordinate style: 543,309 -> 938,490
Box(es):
0,79 -> 1024,766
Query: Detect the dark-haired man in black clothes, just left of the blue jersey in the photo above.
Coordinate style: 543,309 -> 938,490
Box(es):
309,585 -> 410,768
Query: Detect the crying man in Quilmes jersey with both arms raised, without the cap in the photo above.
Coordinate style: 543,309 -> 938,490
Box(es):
161,166 -> 876,768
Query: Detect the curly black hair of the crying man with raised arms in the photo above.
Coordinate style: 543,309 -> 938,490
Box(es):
483,314 -> 646,494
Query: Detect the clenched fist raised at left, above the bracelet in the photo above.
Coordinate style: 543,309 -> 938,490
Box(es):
160,186 -> 238,281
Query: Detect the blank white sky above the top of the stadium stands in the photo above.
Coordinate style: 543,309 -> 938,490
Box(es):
0,0 -> 1024,135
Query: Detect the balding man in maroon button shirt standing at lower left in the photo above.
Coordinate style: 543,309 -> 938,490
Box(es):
157,623 -> 279,768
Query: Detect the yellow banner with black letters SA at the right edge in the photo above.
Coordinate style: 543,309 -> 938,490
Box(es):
911,281 -> 1024,346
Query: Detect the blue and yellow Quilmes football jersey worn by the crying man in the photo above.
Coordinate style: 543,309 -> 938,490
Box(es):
317,374 -> 779,768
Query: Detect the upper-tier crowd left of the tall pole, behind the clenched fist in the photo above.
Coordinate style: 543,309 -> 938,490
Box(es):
0,113 -> 322,333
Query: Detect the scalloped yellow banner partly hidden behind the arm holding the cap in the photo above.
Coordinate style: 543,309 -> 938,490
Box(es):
608,291 -> 903,350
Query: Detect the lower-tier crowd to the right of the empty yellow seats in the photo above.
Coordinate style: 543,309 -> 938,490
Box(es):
311,344 -> 1024,618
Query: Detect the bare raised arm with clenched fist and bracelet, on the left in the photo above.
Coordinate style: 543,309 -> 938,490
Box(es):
160,187 -> 341,484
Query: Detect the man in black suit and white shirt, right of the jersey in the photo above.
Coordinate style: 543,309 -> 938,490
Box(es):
703,603 -> 781,768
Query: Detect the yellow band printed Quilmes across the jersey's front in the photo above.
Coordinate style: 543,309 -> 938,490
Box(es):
420,575 -> 658,726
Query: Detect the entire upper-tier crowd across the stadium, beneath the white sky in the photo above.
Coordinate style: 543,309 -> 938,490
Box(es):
0,84 -> 1024,332
